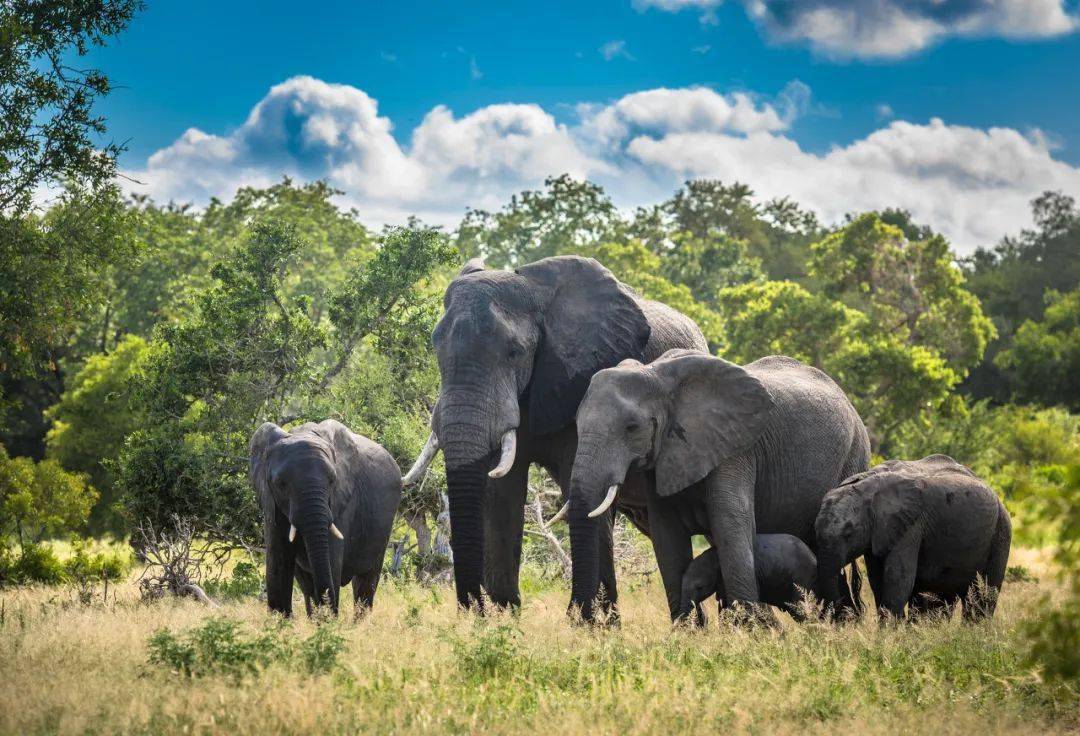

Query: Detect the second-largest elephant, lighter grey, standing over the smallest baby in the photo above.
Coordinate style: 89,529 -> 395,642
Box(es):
568,350 -> 869,619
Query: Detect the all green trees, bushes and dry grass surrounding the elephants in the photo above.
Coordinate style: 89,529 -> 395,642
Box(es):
0,0 -> 1080,733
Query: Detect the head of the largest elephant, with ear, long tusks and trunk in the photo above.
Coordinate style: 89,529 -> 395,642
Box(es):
405,256 -> 650,606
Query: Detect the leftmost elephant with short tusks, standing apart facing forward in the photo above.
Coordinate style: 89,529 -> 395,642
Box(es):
249,419 -> 402,616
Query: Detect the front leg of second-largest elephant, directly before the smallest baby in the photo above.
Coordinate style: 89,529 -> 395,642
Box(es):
704,458 -> 775,623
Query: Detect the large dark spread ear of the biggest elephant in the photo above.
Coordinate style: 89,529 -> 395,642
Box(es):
517,256 -> 651,434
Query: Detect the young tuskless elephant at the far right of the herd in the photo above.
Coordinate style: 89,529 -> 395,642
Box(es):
816,455 -> 1012,619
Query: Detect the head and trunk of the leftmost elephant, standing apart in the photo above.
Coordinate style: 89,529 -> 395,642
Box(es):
249,421 -> 342,614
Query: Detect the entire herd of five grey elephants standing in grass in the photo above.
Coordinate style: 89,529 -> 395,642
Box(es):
251,256 -> 1012,621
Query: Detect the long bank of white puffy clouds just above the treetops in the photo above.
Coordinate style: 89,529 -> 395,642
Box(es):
125,77 -> 1080,251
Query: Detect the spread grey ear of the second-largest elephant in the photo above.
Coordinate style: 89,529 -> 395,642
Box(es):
649,350 -> 773,496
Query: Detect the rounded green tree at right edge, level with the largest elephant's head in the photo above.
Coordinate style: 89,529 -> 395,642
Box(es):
995,289 -> 1080,412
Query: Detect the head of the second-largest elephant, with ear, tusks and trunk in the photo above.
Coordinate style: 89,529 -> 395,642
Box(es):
568,350 -> 773,620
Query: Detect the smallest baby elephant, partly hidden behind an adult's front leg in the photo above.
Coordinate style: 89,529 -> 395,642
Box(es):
681,534 -> 818,621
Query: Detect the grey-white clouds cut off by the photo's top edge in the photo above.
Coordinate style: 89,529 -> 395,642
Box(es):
633,0 -> 1080,58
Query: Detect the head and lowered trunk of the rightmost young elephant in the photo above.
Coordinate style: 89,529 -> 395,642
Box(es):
814,460 -> 921,619
